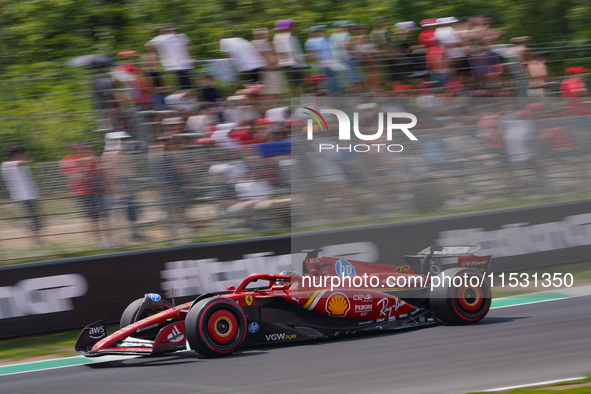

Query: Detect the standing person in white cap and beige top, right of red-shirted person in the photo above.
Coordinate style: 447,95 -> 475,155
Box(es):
101,131 -> 145,241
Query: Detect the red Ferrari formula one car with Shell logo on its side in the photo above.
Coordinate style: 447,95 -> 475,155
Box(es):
75,246 -> 491,357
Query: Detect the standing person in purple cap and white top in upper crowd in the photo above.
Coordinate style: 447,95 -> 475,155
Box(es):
273,19 -> 307,95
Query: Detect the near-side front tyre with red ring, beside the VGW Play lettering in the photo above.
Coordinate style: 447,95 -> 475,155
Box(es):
185,297 -> 246,357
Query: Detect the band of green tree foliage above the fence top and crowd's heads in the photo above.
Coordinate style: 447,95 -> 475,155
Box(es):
0,0 -> 591,67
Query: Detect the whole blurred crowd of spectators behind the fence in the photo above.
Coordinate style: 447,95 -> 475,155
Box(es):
2,16 -> 591,260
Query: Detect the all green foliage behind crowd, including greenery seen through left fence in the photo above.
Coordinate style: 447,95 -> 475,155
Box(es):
0,0 -> 591,160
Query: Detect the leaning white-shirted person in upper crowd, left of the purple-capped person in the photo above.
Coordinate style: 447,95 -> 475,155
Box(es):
220,37 -> 267,83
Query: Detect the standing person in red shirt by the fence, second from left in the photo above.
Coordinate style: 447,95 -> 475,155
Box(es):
59,143 -> 112,248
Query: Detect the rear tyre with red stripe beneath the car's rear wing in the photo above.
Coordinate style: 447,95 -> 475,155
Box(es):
430,268 -> 491,325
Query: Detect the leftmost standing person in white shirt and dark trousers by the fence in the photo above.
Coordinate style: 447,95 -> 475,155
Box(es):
2,145 -> 44,254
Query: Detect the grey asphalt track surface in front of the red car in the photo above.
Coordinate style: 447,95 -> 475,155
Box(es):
0,296 -> 591,394
